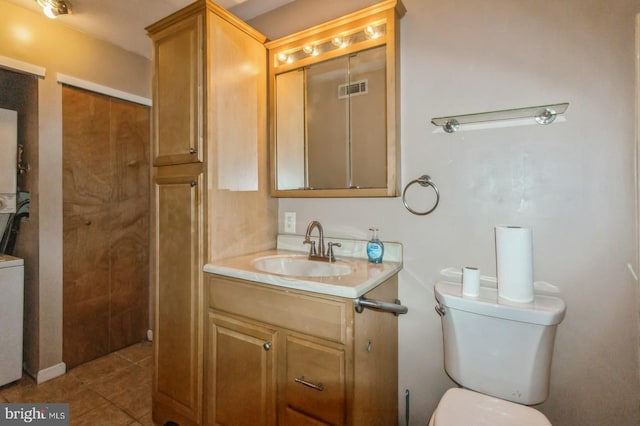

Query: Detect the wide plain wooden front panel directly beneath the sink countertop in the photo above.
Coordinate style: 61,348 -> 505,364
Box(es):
206,274 -> 353,344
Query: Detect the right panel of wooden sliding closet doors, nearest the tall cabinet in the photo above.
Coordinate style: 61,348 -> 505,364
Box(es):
109,99 -> 150,351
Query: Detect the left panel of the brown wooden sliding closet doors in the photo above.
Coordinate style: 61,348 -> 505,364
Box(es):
62,87 -> 114,368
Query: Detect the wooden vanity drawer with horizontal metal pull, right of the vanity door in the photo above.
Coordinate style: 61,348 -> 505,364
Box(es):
285,335 -> 345,425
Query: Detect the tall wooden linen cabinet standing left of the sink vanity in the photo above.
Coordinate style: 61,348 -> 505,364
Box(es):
147,0 -> 277,425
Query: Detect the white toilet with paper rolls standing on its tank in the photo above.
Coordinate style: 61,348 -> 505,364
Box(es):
429,282 -> 566,426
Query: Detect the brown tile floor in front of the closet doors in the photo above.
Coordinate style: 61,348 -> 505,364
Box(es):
0,342 -> 153,426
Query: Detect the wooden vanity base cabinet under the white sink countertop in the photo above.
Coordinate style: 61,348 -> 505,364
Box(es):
205,274 -> 398,426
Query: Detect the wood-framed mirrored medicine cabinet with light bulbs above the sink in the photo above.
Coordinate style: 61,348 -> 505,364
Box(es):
266,0 -> 405,197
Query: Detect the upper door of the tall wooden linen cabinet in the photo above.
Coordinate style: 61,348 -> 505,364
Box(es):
152,14 -> 204,166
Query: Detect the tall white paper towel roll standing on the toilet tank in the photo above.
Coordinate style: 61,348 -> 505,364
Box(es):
496,226 -> 533,303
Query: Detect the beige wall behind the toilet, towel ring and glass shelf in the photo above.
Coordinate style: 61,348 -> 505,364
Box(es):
252,0 -> 640,425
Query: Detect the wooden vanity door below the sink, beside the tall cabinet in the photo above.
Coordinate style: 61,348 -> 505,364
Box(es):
207,312 -> 277,426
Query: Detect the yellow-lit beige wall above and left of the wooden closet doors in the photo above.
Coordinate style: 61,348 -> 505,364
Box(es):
0,0 -> 151,380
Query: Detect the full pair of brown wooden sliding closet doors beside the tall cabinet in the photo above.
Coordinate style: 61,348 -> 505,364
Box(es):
62,87 -> 149,368
